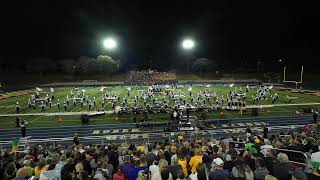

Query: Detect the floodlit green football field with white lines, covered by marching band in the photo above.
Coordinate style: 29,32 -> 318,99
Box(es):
0,84 -> 320,128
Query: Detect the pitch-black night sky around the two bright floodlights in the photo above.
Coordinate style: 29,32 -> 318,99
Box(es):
0,0 -> 320,69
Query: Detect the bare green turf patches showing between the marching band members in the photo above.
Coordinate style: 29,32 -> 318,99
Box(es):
0,85 -> 320,128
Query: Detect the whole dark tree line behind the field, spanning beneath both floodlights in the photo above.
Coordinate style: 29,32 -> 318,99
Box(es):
0,55 -> 225,75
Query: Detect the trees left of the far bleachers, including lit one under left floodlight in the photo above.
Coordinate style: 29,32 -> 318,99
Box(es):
0,55 -> 121,75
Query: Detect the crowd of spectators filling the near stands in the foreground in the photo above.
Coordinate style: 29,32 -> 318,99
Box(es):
0,125 -> 320,180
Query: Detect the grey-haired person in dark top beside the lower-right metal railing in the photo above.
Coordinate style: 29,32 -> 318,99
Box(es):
272,153 -> 290,180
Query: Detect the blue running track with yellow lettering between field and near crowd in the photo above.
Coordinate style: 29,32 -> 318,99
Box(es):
0,116 -> 313,149
